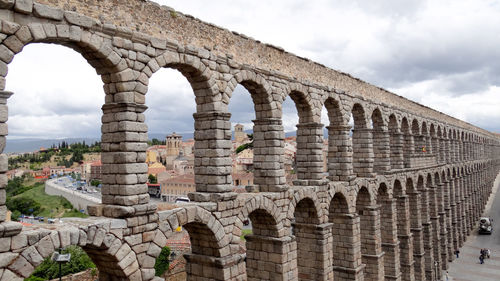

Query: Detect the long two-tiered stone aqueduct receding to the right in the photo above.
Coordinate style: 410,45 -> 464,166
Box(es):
0,0 -> 500,280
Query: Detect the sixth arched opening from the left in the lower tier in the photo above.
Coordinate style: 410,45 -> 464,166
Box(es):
356,186 -> 384,280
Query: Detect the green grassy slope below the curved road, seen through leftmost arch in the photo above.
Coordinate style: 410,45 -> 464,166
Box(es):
10,183 -> 87,218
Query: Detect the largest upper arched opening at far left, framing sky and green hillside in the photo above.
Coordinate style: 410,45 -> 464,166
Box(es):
0,41 -> 113,279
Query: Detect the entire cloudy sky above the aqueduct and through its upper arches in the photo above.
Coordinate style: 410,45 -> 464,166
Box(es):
6,0 -> 500,139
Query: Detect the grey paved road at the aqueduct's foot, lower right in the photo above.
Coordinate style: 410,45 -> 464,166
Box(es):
442,174 -> 500,281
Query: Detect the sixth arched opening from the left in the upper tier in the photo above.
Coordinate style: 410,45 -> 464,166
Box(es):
351,103 -> 373,177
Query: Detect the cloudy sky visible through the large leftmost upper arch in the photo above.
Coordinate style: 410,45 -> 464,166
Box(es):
6,44 -> 104,138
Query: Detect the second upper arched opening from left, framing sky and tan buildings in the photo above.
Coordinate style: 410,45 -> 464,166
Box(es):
144,65 -> 195,203
